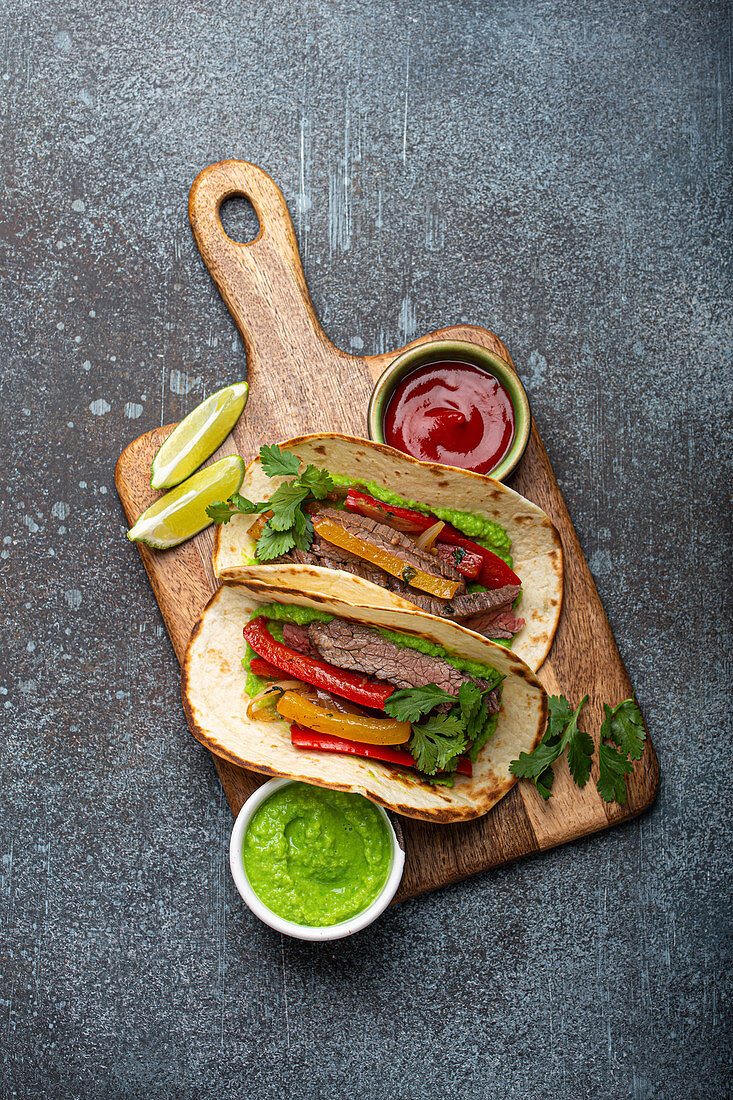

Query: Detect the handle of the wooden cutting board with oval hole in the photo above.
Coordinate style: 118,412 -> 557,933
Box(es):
188,161 -> 343,365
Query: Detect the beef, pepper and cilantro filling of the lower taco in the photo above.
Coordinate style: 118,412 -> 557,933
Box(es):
243,604 -> 503,785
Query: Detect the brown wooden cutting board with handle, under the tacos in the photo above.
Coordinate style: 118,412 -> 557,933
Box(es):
116,161 -> 659,901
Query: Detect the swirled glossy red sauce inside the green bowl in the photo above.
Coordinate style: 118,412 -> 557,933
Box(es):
384,361 -> 514,474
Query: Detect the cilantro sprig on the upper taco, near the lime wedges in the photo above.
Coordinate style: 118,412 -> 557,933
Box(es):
206,443 -> 333,561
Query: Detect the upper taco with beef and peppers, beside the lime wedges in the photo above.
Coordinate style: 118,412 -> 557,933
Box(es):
209,433 -> 562,670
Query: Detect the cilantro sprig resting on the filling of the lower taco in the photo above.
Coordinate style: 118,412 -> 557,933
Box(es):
384,678 -> 503,785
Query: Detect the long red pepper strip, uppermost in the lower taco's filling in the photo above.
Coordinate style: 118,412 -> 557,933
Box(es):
242,616 -> 394,711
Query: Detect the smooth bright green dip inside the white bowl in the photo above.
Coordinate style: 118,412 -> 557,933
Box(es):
244,783 -> 392,927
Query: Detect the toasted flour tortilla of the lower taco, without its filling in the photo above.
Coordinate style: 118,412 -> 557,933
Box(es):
182,581 -> 547,823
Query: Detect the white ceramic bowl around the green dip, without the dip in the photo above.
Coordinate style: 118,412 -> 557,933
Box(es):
229,779 -> 405,941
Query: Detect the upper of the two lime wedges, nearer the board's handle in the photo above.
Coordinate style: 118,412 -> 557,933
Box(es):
150,382 -> 250,488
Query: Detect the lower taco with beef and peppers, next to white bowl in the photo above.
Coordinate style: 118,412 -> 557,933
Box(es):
182,582 -> 547,823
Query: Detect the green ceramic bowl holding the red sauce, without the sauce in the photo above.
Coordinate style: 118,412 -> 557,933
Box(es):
367,340 -> 532,481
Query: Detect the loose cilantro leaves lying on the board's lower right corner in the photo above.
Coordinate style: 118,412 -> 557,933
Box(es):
510,695 -> 646,805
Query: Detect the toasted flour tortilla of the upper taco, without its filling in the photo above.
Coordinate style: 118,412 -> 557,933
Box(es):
214,432 -> 562,671
